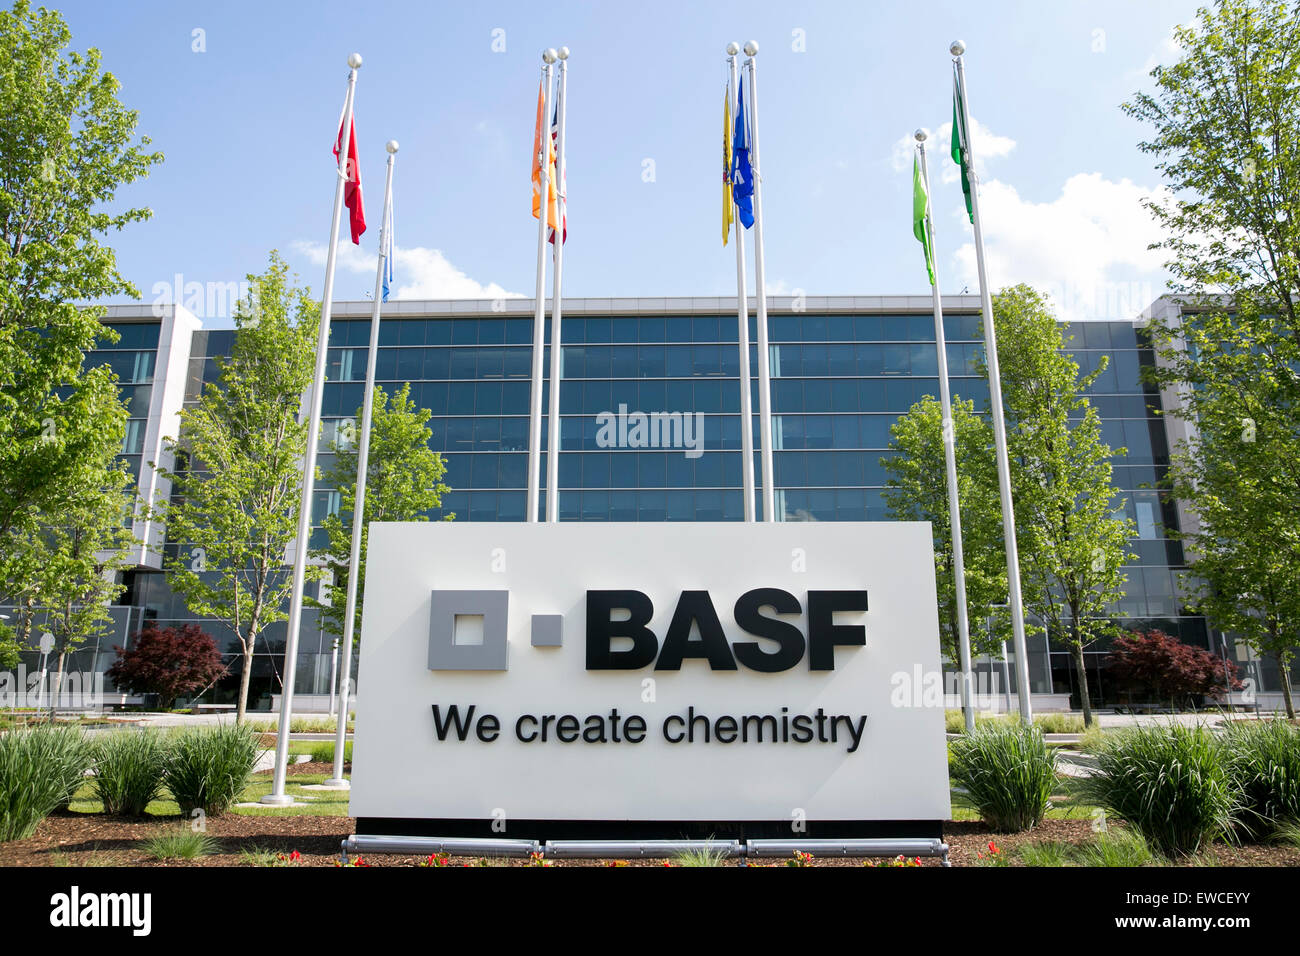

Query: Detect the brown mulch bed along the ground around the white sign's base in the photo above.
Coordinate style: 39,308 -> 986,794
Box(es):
0,816 -> 1300,866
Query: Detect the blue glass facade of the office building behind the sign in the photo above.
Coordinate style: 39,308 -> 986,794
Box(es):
25,307 -> 1284,705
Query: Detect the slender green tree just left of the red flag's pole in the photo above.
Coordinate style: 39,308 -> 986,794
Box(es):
148,252 -> 320,722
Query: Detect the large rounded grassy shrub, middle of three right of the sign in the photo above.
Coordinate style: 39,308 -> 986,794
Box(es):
1080,724 -> 1236,856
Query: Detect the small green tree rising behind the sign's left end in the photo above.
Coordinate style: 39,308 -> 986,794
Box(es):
312,382 -> 455,639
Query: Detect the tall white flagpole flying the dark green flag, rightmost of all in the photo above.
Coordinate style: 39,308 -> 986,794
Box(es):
948,40 -> 1034,723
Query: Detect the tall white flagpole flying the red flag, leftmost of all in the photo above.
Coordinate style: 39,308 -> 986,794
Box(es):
261,53 -> 361,806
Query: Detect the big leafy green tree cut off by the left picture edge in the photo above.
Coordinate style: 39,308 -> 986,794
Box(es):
0,0 -> 163,658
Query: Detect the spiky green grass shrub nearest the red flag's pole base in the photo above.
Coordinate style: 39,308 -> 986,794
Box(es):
164,724 -> 259,817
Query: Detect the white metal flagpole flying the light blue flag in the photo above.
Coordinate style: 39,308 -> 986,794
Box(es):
324,139 -> 398,790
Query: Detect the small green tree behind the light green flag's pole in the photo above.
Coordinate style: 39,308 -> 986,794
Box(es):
880,395 -> 1010,676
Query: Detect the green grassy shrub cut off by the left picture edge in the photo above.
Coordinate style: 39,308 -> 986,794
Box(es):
0,724 -> 92,843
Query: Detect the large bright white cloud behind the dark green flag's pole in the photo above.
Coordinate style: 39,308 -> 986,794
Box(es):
953,173 -> 1165,321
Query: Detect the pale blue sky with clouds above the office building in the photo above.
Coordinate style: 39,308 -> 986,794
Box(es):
57,0 -> 1196,325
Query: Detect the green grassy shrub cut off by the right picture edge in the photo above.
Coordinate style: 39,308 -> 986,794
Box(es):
1225,721 -> 1300,839
